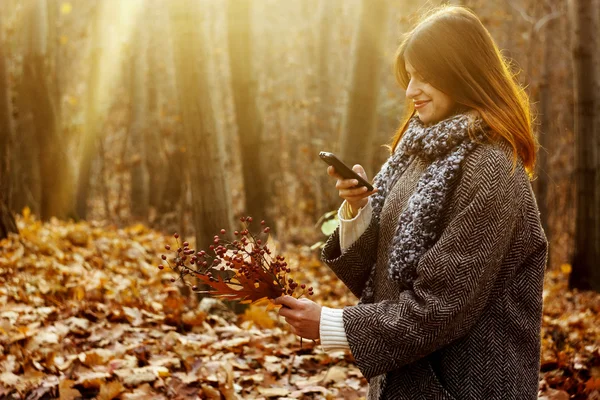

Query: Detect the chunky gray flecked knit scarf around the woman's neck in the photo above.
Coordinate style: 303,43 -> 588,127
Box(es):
361,114 -> 485,303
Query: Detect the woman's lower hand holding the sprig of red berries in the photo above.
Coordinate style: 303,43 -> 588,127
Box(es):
273,296 -> 321,340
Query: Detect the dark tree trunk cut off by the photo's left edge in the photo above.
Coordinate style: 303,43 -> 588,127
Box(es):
0,9 -> 19,239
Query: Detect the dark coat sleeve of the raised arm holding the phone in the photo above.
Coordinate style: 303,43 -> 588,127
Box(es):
321,212 -> 379,298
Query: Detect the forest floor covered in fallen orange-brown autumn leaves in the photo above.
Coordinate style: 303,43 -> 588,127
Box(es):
0,213 -> 600,400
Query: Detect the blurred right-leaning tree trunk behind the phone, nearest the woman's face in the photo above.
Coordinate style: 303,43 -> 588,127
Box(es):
340,0 -> 388,177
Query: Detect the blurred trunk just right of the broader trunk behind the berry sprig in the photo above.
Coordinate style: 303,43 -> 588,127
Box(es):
227,0 -> 275,229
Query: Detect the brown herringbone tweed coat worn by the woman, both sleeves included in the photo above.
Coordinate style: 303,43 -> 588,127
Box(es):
321,142 -> 548,400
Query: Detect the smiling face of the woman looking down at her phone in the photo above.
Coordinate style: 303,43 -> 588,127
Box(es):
404,61 -> 458,126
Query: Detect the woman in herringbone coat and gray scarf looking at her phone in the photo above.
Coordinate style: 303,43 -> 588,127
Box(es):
277,6 -> 548,400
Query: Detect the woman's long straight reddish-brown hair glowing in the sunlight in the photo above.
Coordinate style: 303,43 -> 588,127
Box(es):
390,6 -> 538,176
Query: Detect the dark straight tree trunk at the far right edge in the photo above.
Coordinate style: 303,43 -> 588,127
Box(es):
569,0 -> 600,291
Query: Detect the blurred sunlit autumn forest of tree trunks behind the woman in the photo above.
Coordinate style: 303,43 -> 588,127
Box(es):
0,0 -> 600,398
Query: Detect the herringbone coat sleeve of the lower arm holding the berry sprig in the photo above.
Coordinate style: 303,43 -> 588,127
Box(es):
343,150 -> 520,379
